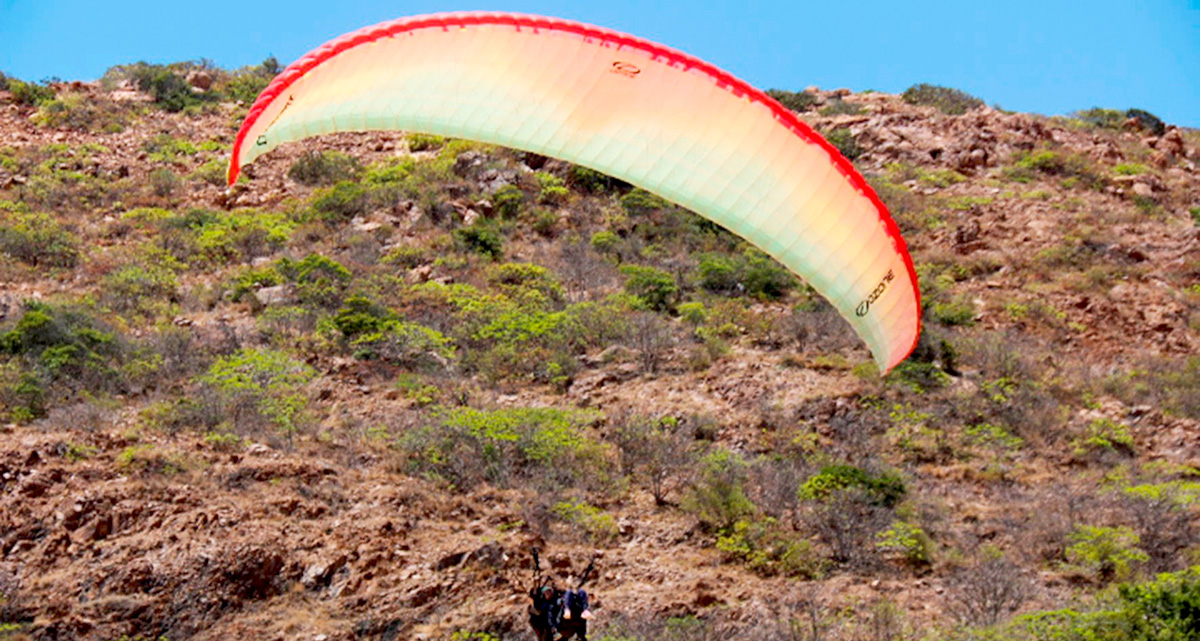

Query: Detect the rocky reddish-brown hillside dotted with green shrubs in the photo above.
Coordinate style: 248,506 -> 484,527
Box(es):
0,70 -> 1200,641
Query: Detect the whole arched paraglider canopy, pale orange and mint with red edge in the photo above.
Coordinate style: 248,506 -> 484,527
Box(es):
229,13 -> 920,371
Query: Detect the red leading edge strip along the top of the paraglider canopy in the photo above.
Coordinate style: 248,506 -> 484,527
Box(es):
228,12 -> 920,369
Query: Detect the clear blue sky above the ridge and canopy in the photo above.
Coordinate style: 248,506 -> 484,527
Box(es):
0,0 -> 1200,127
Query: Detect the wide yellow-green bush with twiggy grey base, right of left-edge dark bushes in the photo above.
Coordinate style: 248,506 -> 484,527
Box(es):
197,349 -> 317,442
